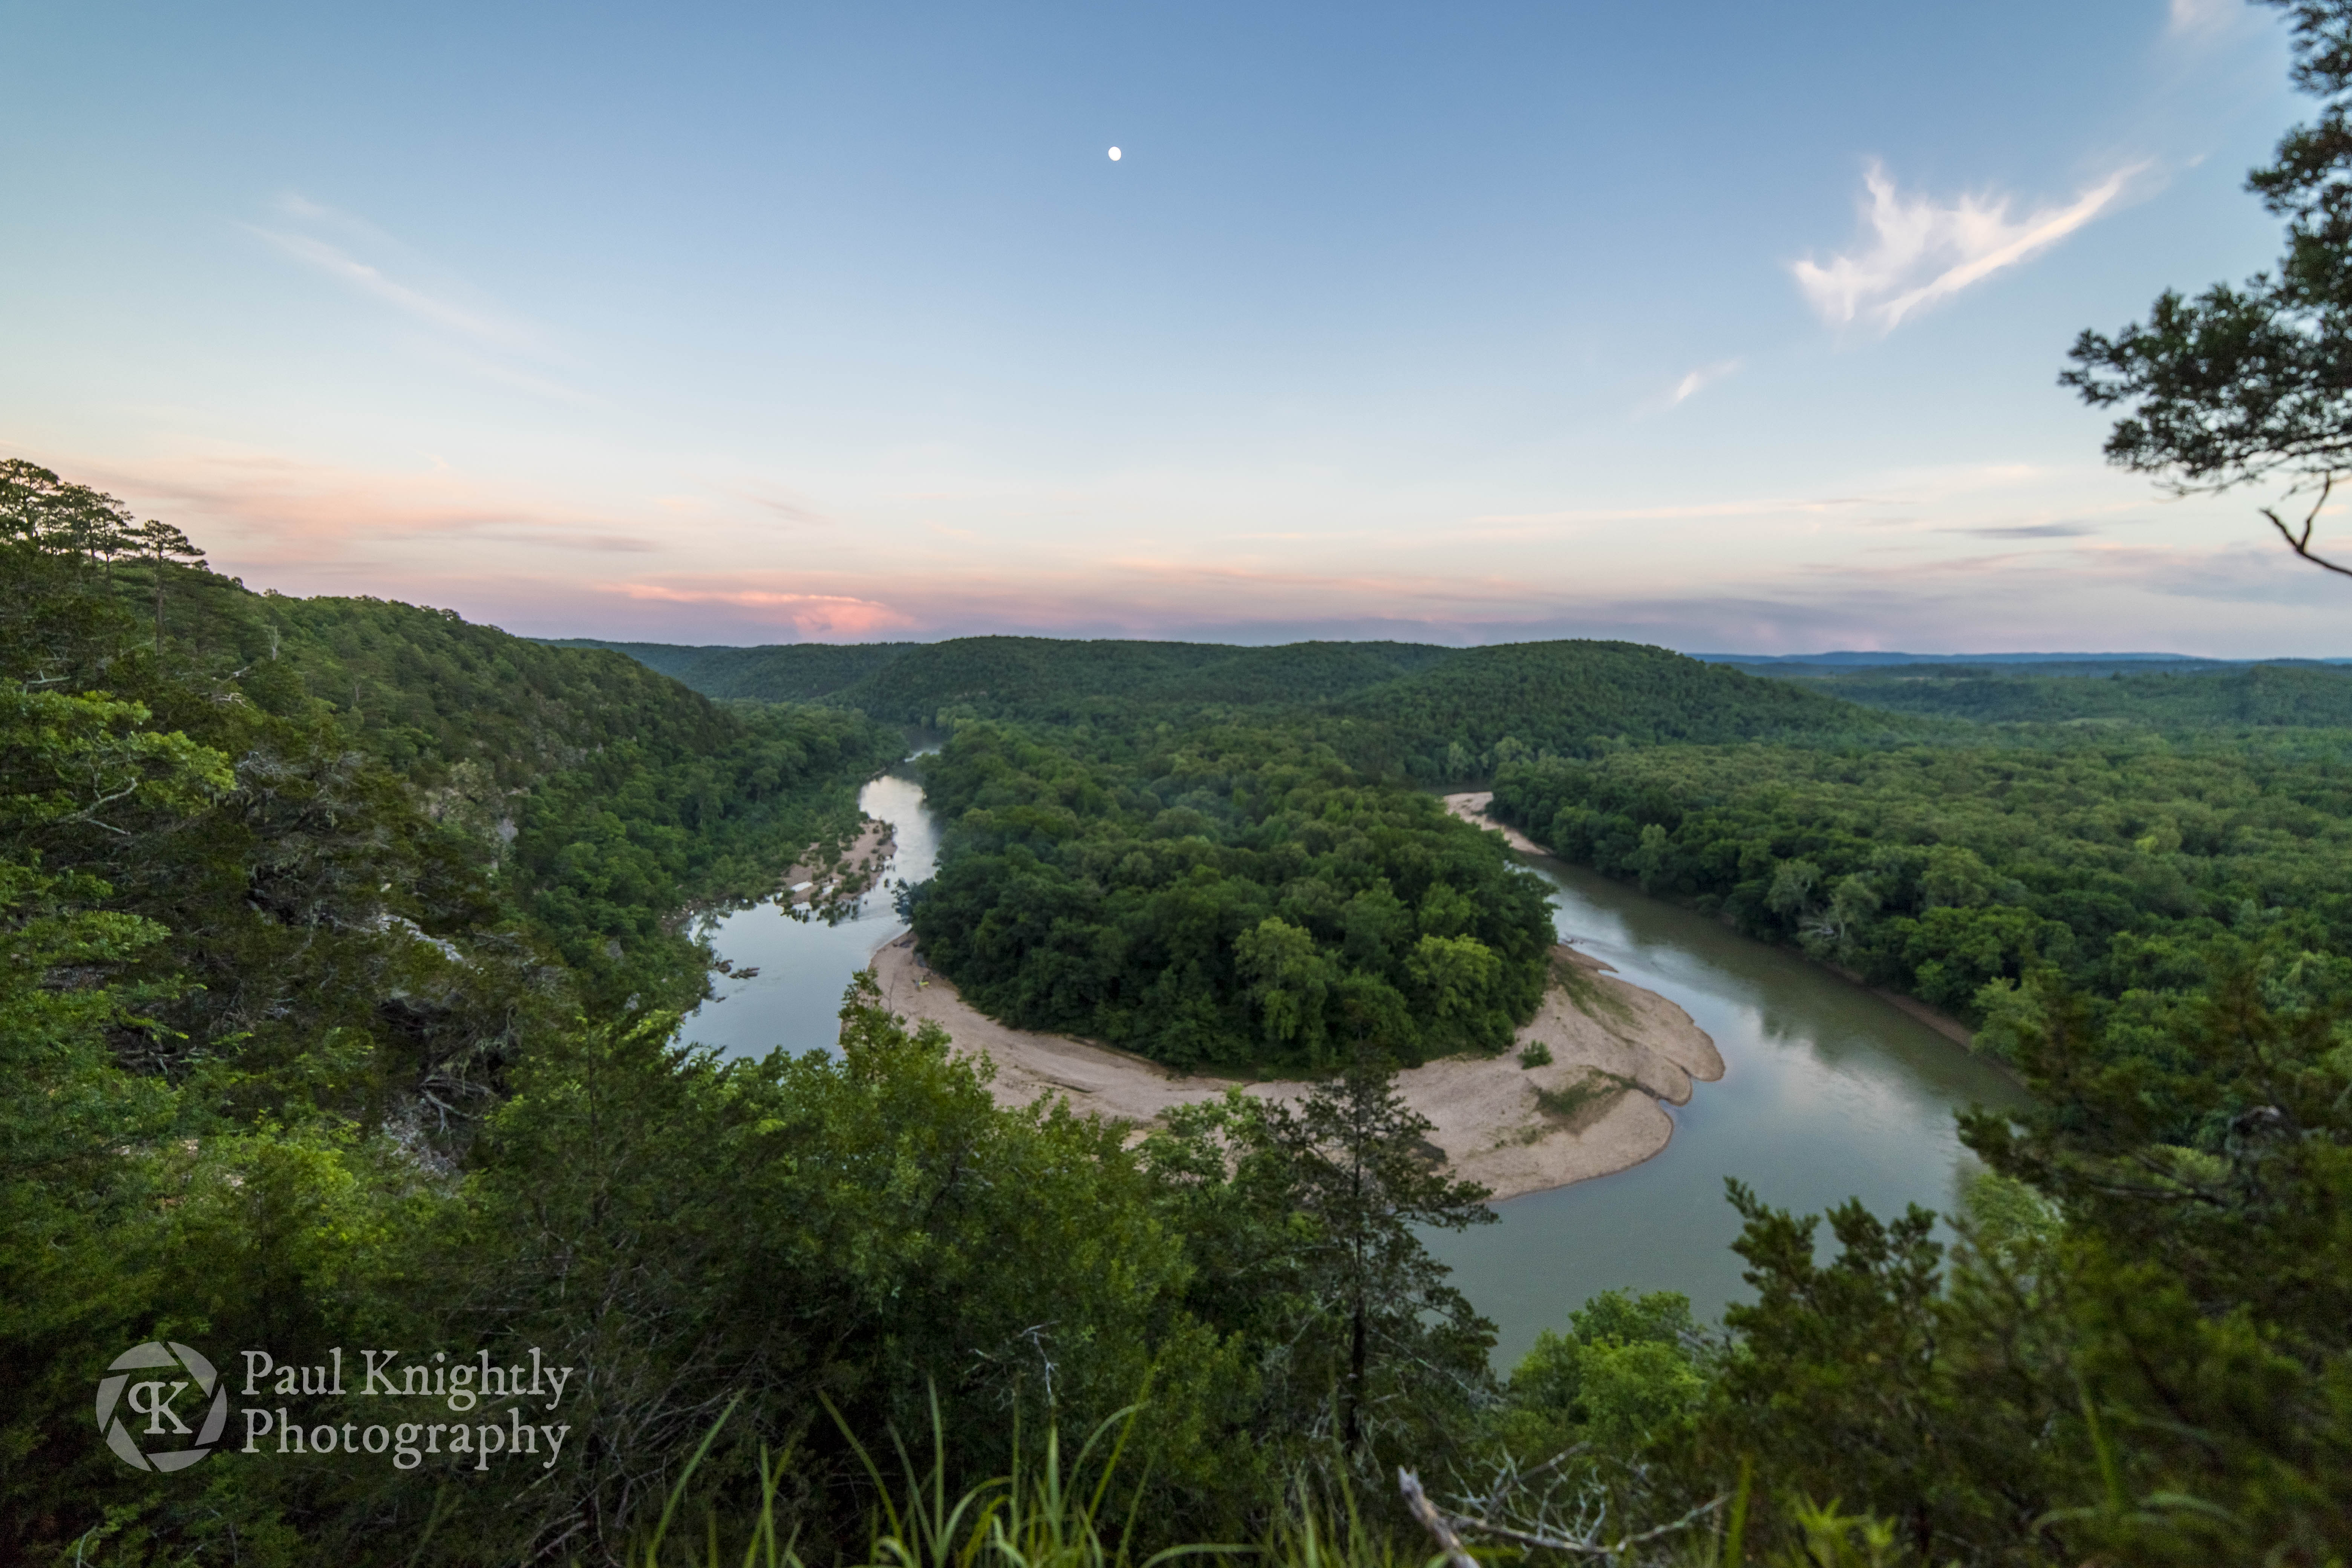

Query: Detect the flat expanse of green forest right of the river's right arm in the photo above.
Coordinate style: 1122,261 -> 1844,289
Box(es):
1496,736 -> 2352,1020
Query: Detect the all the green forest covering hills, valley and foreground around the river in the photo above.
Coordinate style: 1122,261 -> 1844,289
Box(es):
14,447 -> 2352,1568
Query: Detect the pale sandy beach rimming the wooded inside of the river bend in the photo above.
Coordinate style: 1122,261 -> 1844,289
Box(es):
873,933 -> 1724,1199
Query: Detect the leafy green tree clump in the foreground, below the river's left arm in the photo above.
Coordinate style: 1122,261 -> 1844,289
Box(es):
409,987 -> 1237,1559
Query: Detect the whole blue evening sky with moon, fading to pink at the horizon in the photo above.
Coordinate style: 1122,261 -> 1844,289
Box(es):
0,0 -> 2352,658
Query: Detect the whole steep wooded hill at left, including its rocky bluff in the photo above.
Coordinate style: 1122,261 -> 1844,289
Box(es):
0,463 -> 901,1041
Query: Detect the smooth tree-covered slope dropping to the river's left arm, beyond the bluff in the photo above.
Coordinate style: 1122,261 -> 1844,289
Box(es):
62,557 -> 903,1006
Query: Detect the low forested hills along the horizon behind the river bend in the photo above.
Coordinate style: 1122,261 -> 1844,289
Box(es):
574,637 -> 1922,778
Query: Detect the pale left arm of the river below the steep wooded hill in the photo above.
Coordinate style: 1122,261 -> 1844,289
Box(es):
684,773 -> 939,1055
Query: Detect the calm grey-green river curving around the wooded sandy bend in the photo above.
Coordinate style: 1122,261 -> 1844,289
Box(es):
687,773 -> 2025,1366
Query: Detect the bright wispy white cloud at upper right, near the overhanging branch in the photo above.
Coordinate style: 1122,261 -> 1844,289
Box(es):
1790,162 -> 2147,331
